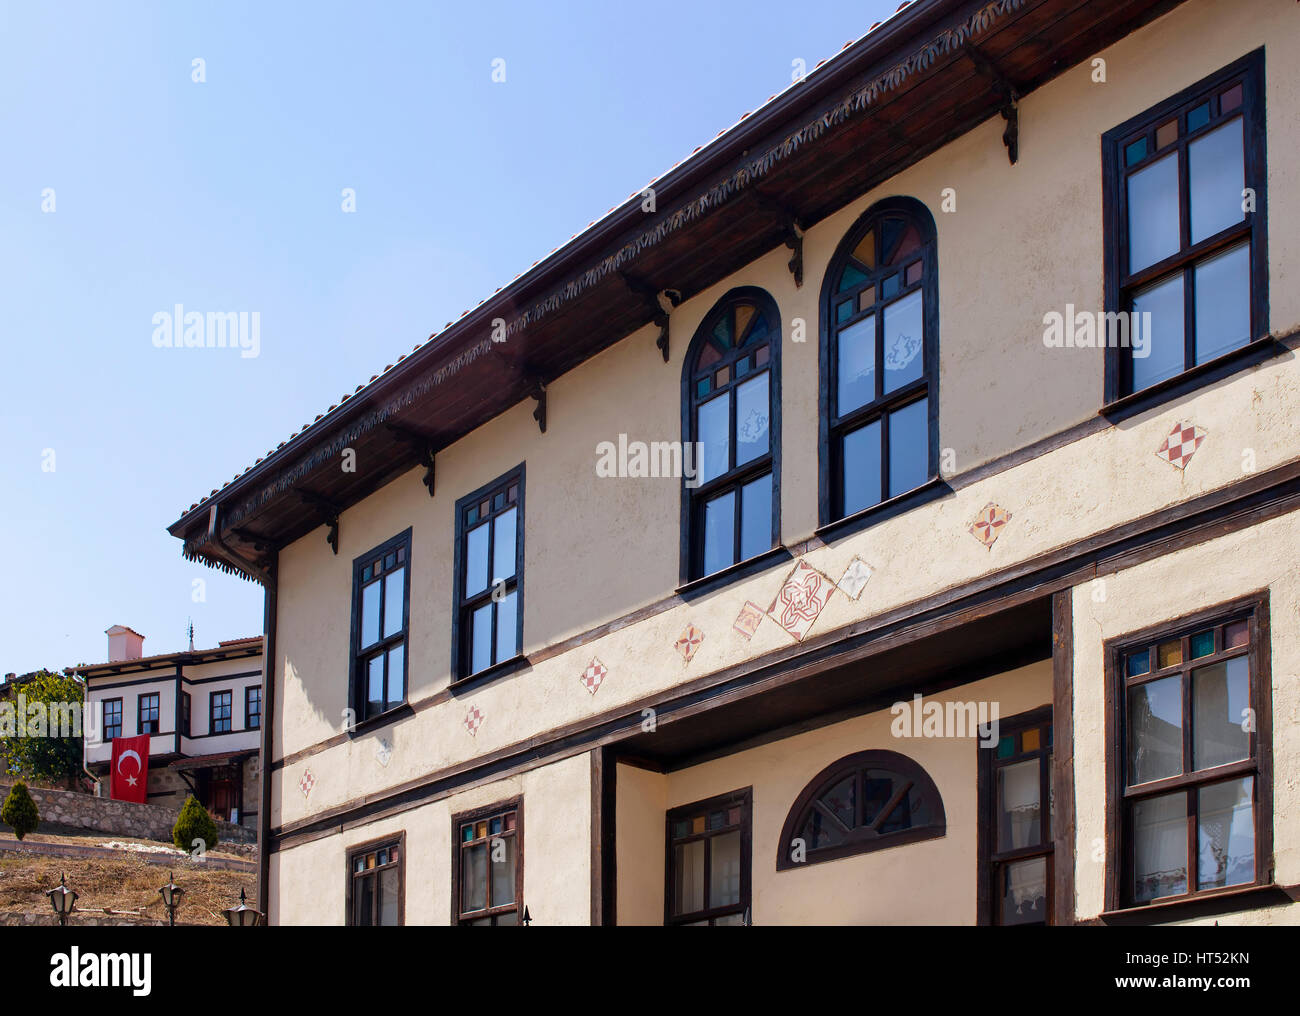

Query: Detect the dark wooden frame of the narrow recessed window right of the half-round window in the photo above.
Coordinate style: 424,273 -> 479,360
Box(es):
976,705 -> 1055,925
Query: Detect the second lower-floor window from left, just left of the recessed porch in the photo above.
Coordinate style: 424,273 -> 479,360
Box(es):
451,798 -> 524,926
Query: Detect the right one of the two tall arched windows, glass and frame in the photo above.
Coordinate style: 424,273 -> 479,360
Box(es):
820,197 -> 939,525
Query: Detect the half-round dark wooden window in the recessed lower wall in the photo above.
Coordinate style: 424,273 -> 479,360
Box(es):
776,751 -> 946,872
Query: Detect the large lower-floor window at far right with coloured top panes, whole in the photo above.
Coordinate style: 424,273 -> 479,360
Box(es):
1108,598 -> 1273,909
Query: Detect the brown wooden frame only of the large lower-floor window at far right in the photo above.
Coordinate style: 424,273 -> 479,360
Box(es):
1104,590 -> 1273,916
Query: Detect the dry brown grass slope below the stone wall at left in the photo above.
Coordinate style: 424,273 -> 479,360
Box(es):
0,857 -> 257,925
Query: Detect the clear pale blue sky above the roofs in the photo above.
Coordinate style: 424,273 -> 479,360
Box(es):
0,0 -> 898,673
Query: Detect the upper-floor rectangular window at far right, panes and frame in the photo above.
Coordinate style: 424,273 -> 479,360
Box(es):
1099,49 -> 1268,401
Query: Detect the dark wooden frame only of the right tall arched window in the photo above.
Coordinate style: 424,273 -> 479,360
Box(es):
818,197 -> 944,538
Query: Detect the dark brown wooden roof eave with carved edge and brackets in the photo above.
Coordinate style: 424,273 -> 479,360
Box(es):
169,0 -> 1182,581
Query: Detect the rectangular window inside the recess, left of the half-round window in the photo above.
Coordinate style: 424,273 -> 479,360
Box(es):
664,787 -> 754,925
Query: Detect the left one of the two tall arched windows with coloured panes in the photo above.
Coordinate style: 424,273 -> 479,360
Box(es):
681,287 -> 781,582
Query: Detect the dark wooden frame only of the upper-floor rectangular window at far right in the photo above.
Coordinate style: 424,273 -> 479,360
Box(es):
1101,48 -> 1273,418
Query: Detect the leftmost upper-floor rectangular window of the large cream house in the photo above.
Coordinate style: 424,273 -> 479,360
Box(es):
352,529 -> 411,720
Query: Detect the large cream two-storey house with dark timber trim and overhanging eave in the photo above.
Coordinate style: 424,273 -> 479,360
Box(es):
172,0 -> 1300,925
